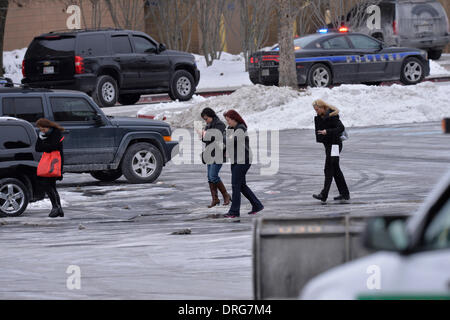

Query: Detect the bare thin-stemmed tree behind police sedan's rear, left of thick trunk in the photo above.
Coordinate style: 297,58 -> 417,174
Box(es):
239,0 -> 275,71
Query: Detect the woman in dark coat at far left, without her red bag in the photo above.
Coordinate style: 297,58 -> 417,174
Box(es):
36,118 -> 64,218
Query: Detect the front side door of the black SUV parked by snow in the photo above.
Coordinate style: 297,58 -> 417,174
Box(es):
132,35 -> 170,88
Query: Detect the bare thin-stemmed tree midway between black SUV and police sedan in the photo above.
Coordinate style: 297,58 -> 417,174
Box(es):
197,0 -> 229,66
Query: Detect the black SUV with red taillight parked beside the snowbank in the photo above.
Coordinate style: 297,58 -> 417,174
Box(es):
22,29 -> 200,107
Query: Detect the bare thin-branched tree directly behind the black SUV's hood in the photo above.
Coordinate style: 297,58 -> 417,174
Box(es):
147,0 -> 197,51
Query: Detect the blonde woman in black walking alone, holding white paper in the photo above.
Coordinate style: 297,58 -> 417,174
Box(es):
313,100 -> 350,204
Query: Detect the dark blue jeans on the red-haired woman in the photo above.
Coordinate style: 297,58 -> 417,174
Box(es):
228,164 -> 263,215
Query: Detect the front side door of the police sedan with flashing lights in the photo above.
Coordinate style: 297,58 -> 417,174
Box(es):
348,34 -> 389,82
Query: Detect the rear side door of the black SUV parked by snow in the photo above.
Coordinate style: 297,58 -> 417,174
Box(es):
111,34 -> 139,88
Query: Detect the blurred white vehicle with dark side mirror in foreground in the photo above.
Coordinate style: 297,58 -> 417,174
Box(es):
300,172 -> 450,300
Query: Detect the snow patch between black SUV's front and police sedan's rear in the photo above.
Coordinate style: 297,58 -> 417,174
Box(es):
194,52 -> 252,90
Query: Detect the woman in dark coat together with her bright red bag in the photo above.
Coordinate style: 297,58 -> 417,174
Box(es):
36,118 -> 64,218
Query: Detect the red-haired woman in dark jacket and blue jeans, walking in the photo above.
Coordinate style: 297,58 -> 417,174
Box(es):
224,110 -> 264,218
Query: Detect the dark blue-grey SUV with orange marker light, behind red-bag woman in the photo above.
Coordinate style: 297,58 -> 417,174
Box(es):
0,88 -> 178,183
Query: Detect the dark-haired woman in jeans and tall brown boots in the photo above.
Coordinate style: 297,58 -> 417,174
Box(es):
200,108 -> 231,208
